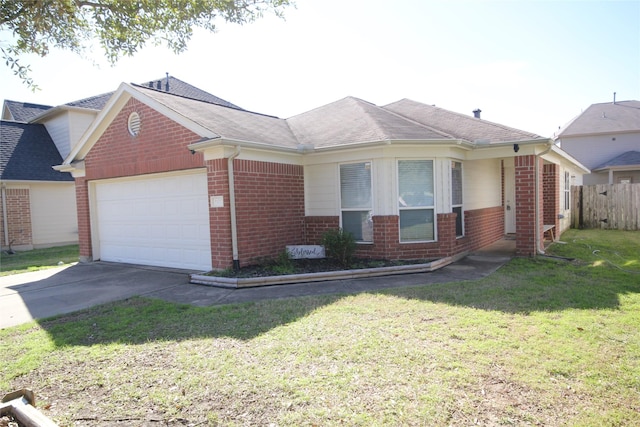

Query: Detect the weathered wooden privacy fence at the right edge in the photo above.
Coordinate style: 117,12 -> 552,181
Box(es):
571,184 -> 640,230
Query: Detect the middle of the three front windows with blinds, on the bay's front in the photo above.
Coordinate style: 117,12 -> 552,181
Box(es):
398,160 -> 435,242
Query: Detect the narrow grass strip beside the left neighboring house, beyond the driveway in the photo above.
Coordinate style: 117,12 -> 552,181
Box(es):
0,245 -> 78,276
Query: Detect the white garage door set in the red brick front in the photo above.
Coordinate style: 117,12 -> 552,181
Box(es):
96,172 -> 211,270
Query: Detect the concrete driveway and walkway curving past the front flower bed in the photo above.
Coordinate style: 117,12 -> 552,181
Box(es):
0,240 -> 515,328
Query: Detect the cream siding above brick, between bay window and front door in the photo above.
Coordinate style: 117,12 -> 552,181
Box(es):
462,159 -> 502,210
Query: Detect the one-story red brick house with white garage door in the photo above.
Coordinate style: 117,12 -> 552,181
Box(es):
55,79 -> 587,270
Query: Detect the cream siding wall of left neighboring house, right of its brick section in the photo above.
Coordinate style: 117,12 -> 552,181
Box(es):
29,182 -> 78,247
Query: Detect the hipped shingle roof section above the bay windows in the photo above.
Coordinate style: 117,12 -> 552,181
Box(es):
287,97 -> 452,147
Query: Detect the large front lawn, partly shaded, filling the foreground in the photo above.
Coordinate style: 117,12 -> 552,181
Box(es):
0,230 -> 640,426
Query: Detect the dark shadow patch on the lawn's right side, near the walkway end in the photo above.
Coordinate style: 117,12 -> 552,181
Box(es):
384,258 -> 640,314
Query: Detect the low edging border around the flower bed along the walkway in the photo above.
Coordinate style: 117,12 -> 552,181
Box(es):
189,252 -> 468,289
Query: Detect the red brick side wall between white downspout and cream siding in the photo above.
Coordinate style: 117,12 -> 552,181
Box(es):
233,159 -> 305,265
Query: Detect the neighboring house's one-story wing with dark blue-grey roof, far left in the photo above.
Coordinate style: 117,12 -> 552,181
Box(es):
0,120 -> 78,250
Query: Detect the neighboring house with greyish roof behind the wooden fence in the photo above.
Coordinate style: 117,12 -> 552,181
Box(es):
556,101 -> 640,185
